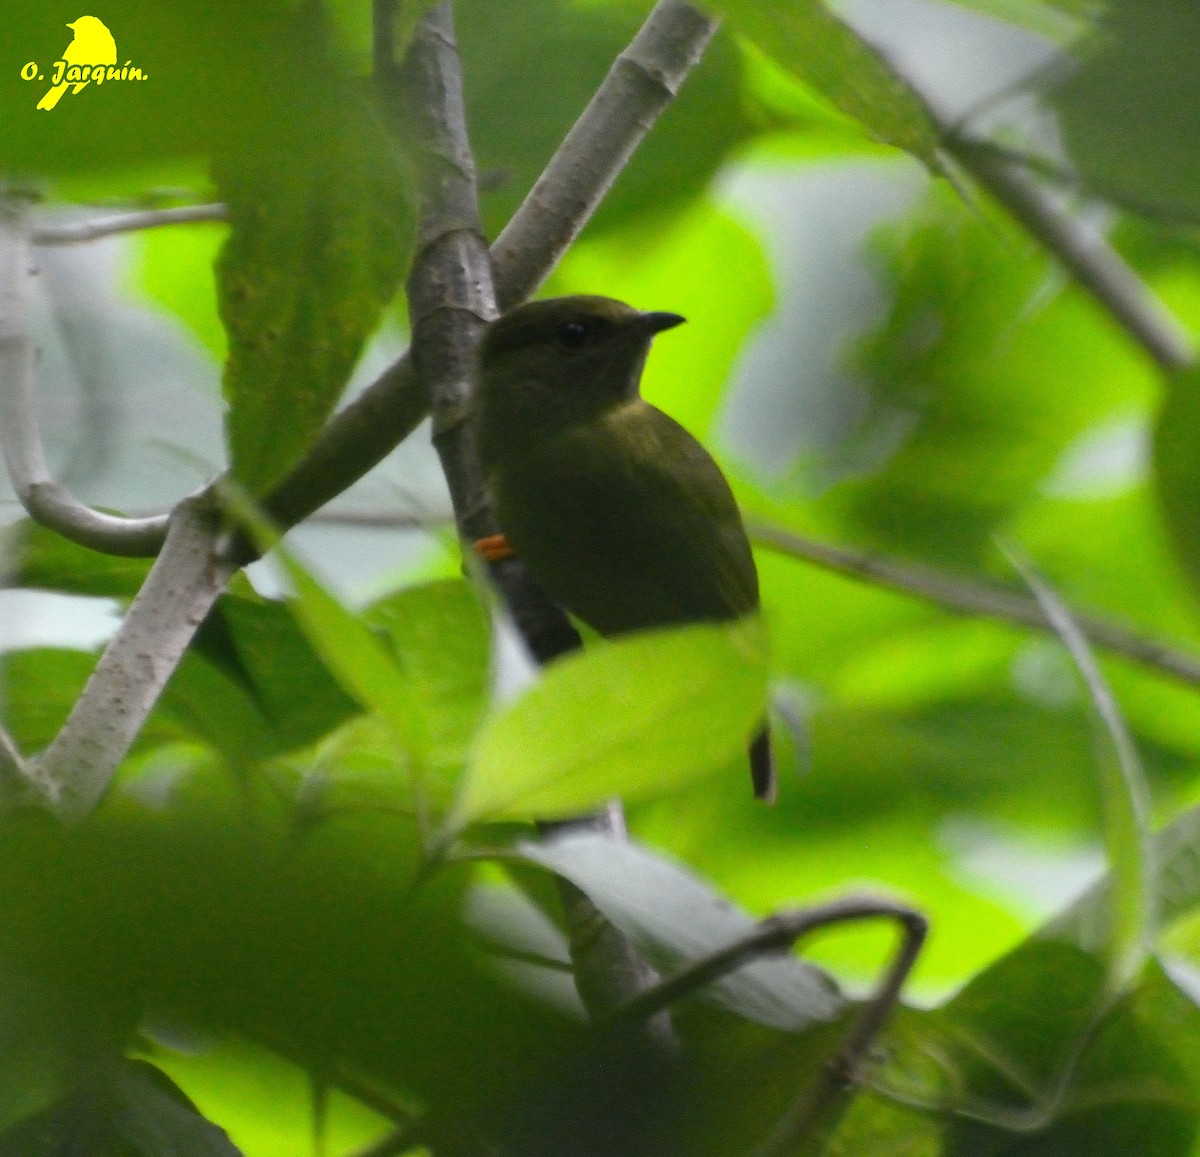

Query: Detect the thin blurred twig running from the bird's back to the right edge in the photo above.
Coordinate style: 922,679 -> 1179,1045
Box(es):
748,520 -> 1200,687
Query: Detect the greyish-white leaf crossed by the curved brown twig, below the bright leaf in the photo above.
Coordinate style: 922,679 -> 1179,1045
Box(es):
521,834 -> 842,1032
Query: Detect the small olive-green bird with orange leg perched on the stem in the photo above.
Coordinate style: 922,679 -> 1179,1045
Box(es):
473,294 -> 775,802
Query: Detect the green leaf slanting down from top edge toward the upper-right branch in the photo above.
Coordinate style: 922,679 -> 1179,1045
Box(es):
707,0 -> 938,169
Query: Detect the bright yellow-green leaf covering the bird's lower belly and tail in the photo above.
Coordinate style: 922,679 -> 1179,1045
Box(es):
455,621 -> 767,825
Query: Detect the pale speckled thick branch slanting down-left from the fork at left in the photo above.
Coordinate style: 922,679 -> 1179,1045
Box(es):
31,496 -> 233,821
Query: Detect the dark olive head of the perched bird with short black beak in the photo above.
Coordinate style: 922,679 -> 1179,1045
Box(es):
479,295 -> 684,453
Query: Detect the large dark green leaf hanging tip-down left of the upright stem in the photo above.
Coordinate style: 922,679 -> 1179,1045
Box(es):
215,8 -> 413,493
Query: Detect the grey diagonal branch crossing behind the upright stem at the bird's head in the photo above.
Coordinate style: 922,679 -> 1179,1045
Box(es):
249,0 -> 712,552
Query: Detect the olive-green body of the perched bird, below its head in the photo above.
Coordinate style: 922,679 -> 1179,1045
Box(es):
493,400 -> 758,634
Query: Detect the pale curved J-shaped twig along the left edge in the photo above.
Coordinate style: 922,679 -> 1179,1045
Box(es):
0,199 -> 167,557
